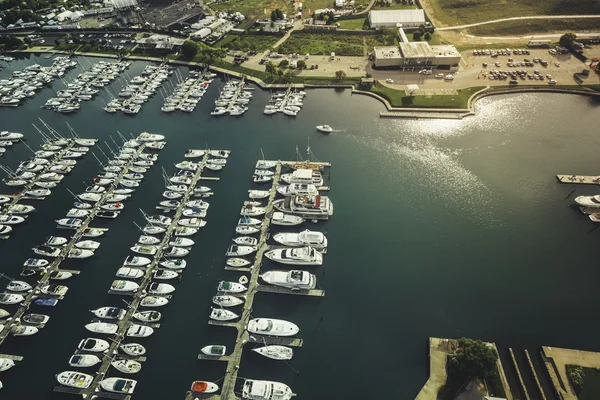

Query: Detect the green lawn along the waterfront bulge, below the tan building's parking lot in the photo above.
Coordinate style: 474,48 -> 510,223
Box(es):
371,84 -> 483,108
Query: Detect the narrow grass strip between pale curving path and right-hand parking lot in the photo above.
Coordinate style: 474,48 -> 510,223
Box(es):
468,18 -> 600,36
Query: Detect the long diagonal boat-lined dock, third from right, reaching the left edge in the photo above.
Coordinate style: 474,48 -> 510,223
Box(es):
0,145 -> 146,344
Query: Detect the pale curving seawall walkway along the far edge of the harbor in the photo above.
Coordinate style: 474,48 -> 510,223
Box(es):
11,49 -> 600,119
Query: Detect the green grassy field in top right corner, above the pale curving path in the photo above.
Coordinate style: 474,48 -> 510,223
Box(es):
426,0 -> 600,25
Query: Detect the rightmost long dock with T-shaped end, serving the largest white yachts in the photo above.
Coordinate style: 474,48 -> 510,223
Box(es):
195,161 -> 331,400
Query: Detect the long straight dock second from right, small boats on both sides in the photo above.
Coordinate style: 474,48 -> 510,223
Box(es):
59,151 -> 226,400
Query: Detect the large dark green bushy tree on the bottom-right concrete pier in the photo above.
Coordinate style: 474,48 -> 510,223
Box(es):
451,338 -> 498,379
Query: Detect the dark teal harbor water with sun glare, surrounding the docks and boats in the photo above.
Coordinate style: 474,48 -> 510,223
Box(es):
0,56 -> 600,400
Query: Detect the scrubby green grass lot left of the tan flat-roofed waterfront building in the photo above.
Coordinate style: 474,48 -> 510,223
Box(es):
278,32 -> 364,56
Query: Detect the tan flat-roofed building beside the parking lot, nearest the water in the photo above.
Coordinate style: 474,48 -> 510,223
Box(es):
373,42 -> 461,71
